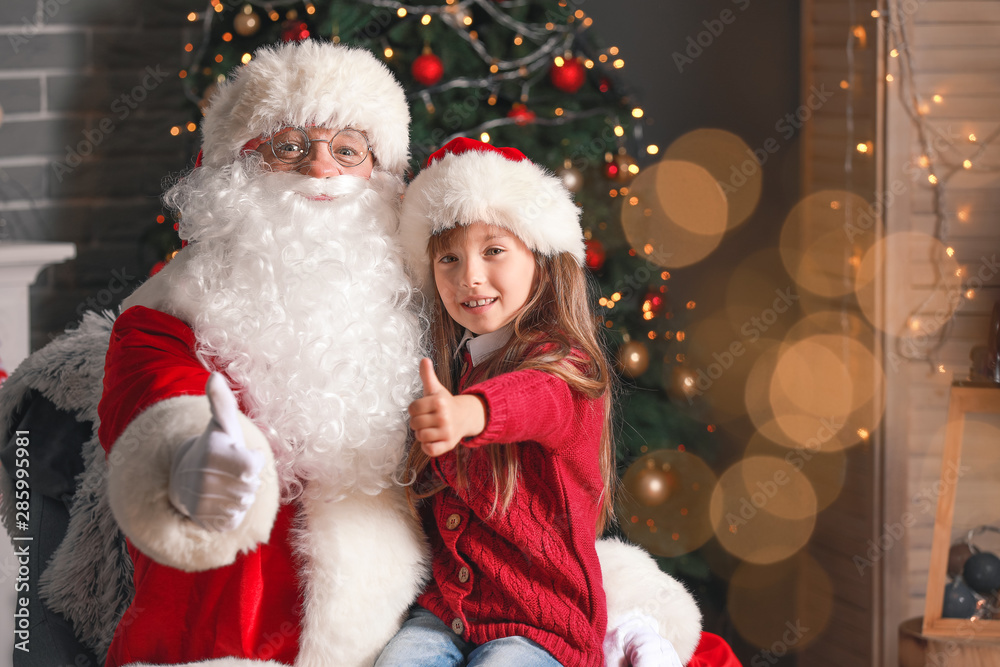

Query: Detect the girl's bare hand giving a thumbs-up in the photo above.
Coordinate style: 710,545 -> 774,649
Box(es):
409,358 -> 486,457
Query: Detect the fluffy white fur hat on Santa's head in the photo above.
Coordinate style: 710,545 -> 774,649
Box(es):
202,40 -> 410,174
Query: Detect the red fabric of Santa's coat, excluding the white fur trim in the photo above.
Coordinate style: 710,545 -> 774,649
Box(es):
98,306 -> 301,667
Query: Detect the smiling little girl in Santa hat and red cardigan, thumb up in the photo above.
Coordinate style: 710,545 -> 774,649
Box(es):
377,139 -> 614,667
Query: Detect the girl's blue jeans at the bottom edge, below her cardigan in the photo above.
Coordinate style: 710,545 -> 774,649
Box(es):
375,606 -> 562,667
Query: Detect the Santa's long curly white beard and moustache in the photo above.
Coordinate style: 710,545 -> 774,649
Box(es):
166,162 -> 422,500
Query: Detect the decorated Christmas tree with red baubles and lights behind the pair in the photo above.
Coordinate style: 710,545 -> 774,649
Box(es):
157,0 -> 721,620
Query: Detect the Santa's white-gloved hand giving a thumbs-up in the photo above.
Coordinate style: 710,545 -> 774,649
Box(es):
169,373 -> 264,532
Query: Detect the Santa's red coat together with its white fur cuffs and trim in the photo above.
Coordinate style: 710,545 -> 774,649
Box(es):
99,306 -> 731,667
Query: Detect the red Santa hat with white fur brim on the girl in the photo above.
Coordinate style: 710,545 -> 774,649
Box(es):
399,137 -> 584,288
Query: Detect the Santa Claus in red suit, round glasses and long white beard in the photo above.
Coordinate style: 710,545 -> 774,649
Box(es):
1,42 -> 720,667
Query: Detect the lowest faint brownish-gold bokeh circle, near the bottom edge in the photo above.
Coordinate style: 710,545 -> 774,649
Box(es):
726,553 -> 833,652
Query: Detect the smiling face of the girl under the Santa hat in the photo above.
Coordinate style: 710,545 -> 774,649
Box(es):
431,222 -> 535,335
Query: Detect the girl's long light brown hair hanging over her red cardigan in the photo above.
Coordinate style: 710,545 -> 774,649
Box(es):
406,225 -> 617,534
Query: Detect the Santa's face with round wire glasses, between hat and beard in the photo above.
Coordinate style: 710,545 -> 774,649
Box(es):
256,127 -> 375,179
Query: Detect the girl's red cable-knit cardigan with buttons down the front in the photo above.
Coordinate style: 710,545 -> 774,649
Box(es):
419,370 -> 607,667
